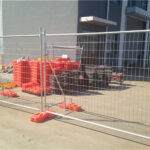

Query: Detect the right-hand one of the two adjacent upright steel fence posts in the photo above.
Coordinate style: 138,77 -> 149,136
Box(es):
44,29 -> 47,110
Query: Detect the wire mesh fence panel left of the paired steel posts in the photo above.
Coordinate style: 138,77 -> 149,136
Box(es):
0,34 -> 44,109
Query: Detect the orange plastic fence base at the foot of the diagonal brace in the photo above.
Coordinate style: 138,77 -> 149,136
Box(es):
59,102 -> 82,111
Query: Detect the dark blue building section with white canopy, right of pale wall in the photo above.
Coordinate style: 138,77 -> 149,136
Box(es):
78,0 -> 150,68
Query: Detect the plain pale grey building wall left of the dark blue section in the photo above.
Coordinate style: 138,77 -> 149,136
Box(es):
3,0 -> 78,63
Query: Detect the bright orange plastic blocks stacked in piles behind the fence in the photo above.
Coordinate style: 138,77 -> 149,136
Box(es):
13,58 -> 79,95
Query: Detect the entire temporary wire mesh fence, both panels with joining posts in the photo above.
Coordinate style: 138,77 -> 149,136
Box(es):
0,30 -> 150,140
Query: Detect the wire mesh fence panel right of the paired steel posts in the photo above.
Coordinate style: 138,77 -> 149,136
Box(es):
45,31 -> 150,139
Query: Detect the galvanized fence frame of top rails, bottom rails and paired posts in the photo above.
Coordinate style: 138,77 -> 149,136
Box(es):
0,28 -> 150,139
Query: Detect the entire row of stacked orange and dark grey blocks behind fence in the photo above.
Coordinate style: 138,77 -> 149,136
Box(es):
13,58 -> 112,95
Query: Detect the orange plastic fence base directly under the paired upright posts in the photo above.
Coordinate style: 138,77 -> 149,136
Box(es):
30,110 -> 55,123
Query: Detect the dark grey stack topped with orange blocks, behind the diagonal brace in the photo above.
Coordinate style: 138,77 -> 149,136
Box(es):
50,58 -> 79,95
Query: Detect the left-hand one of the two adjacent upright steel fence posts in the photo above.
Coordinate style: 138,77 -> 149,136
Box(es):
40,27 -> 43,111
